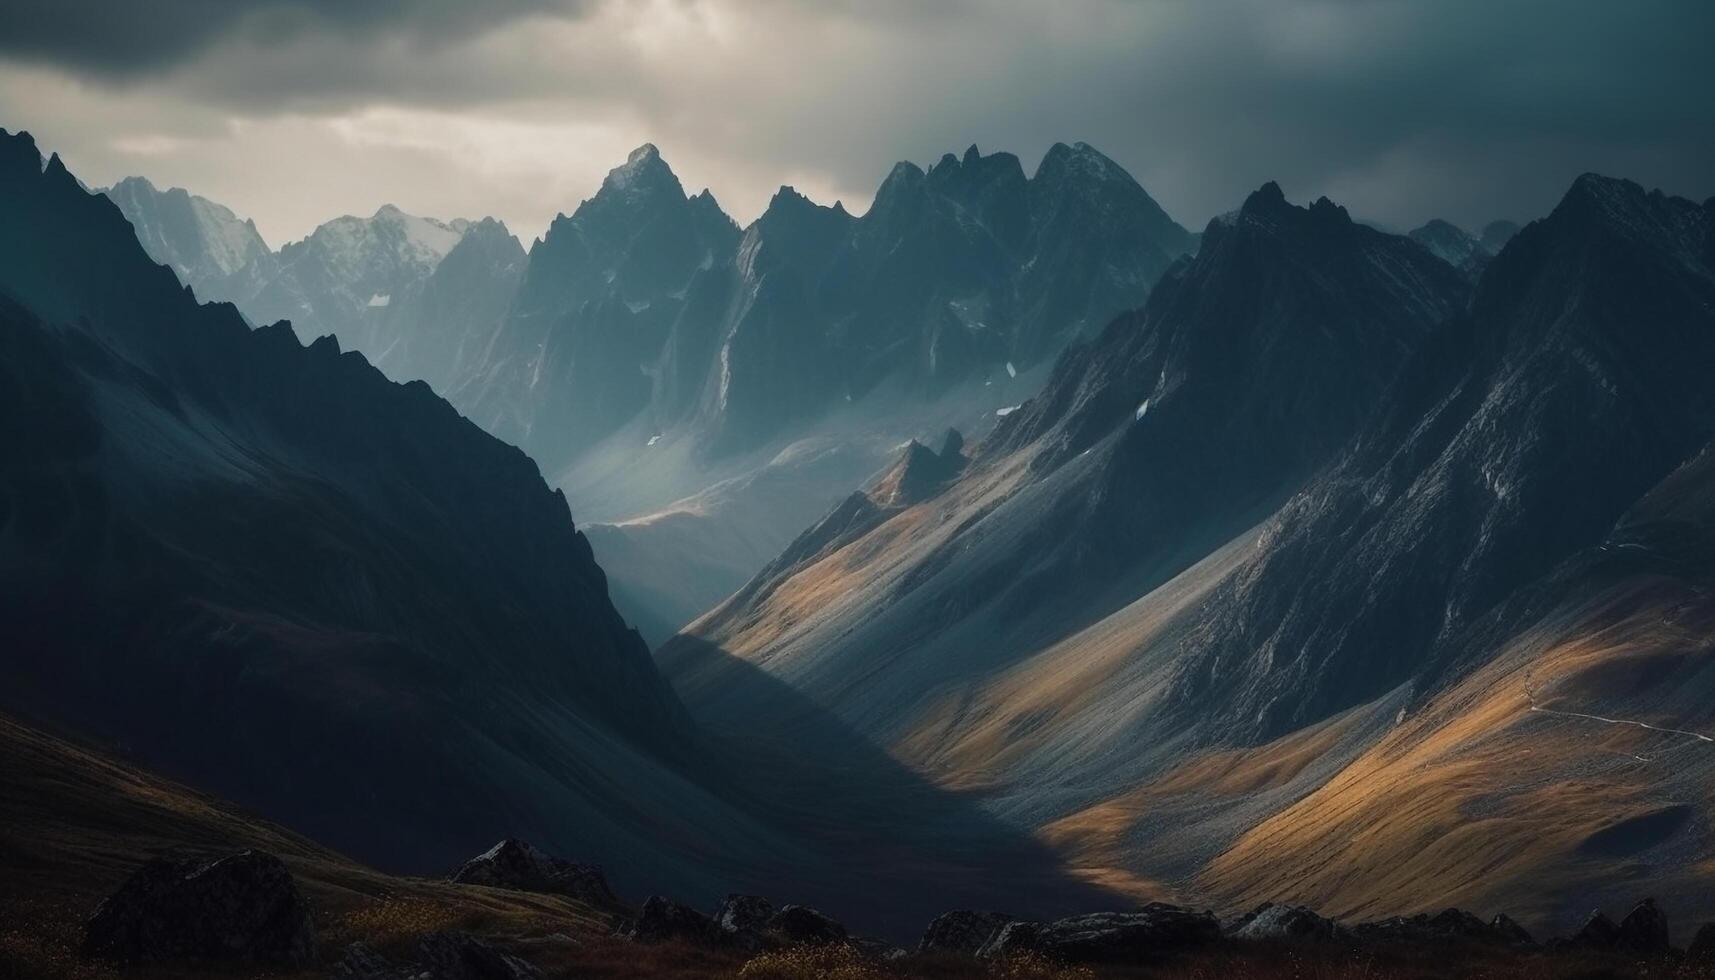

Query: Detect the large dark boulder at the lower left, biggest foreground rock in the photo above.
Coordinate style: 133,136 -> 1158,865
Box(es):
84,851 -> 316,966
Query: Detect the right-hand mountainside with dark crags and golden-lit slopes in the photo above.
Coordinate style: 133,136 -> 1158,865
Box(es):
657,175 -> 1715,927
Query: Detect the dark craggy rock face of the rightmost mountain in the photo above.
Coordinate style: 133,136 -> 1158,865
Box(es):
1173,175 -> 1715,733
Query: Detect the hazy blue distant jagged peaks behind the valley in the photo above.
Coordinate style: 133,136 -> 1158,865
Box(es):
103,144 -> 1195,642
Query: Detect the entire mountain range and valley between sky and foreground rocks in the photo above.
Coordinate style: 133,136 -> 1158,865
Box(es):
50,114 -> 1715,932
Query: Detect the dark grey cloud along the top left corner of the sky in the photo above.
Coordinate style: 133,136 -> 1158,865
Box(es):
0,0 -> 583,77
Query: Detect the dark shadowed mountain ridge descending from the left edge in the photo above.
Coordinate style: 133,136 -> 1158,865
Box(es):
0,126 -> 764,877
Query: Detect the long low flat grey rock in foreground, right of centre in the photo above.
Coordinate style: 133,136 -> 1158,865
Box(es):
979,903 -> 1221,963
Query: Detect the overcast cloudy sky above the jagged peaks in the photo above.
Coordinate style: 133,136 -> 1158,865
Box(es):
0,0 -> 1715,245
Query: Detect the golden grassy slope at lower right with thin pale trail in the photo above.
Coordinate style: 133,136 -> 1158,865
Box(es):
1199,578 -> 1715,935
